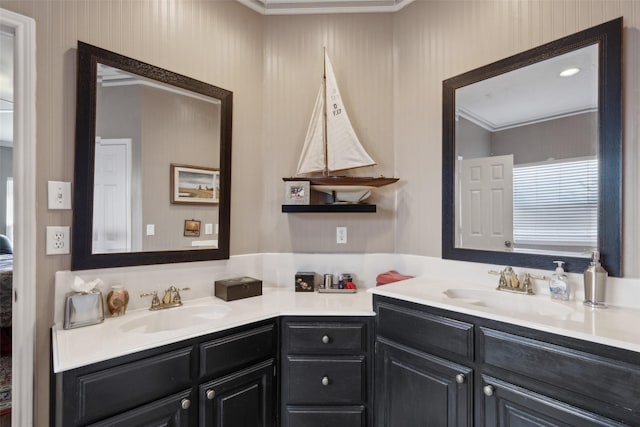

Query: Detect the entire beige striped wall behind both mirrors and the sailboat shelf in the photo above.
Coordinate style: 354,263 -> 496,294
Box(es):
0,0 -> 640,426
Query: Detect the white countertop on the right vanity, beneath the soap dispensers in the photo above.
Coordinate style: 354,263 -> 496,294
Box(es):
369,278 -> 640,352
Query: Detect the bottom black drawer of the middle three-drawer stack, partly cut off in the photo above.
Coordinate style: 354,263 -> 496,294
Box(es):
285,406 -> 366,427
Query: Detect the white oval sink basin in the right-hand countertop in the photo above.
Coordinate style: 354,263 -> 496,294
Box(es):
444,289 -> 575,318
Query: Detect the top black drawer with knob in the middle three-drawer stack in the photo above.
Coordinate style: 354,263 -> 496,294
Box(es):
283,322 -> 367,354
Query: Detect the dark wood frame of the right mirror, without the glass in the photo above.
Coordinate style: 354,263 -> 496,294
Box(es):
442,18 -> 622,277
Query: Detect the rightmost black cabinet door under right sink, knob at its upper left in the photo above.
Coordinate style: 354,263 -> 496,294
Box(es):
482,375 -> 626,427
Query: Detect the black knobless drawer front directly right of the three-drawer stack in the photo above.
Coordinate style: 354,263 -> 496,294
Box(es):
376,302 -> 473,360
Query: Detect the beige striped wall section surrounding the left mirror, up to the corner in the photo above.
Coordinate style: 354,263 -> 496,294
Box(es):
0,0 -> 264,426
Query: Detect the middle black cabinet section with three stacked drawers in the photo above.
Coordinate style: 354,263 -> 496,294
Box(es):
281,317 -> 372,427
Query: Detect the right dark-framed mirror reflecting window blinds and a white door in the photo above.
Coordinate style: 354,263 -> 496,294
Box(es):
442,18 -> 622,276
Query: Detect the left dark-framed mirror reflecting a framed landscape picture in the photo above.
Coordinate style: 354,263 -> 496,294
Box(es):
72,42 -> 233,270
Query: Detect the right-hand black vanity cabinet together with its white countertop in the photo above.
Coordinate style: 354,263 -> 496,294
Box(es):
374,279 -> 640,427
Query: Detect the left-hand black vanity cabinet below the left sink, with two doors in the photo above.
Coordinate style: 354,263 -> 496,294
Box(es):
53,320 -> 278,427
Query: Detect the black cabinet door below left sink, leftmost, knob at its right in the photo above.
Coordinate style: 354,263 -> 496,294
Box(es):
89,390 -> 192,427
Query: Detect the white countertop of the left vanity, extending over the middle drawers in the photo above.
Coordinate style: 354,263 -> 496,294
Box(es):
52,287 -> 374,373
